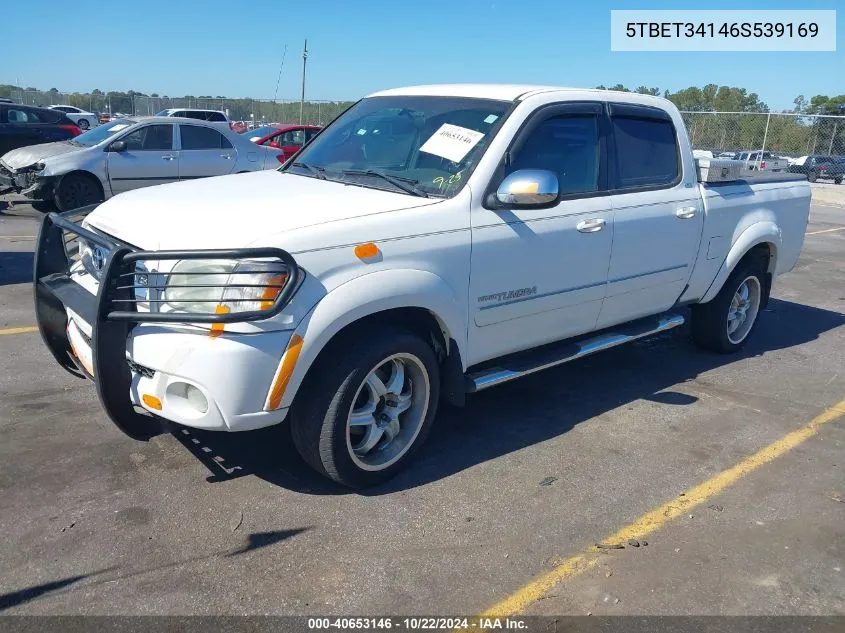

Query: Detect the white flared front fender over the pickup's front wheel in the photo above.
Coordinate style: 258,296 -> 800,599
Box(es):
268,269 -> 467,408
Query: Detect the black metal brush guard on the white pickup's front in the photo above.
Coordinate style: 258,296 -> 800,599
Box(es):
34,205 -> 301,440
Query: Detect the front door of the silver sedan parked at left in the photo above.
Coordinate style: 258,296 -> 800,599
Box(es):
106,123 -> 179,195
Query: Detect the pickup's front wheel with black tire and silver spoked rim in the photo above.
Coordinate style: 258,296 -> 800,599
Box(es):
291,327 -> 440,488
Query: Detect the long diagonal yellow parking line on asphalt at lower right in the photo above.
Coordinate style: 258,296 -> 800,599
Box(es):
479,400 -> 845,617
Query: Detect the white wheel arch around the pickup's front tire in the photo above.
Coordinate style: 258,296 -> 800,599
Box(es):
265,270 -> 467,408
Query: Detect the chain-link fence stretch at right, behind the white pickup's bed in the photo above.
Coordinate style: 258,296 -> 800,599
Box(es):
681,112 -> 845,158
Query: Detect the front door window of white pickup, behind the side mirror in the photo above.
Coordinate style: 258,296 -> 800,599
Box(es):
508,115 -> 600,194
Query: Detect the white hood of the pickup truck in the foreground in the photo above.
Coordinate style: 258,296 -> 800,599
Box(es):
85,170 -> 440,250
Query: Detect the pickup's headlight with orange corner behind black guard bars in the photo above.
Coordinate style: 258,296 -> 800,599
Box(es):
162,259 -> 289,314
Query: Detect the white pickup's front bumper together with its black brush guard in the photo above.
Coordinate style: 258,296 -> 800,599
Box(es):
35,206 -> 297,439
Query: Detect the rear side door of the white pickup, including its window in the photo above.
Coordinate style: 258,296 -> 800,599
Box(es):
597,103 -> 704,328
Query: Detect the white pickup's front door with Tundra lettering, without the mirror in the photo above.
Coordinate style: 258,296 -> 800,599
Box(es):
469,103 -> 613,362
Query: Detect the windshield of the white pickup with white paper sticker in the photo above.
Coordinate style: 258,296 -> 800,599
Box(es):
283,96 -> 513,197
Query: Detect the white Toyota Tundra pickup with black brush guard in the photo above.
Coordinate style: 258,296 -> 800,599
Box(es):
35,85 -> 810,487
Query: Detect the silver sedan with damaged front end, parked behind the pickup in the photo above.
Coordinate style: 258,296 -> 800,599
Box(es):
0,117 -> 284,211
